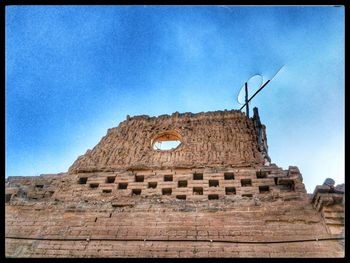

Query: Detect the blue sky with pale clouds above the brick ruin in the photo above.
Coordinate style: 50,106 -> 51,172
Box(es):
5,6 -> 345,192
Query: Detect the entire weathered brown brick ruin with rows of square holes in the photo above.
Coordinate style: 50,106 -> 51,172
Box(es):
5,109 -> 344,257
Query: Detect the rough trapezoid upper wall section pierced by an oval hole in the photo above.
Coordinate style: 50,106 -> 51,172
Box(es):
70,110 -> 263,172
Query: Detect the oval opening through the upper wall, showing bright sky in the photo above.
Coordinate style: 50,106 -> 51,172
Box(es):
151,131 -> 182,151
